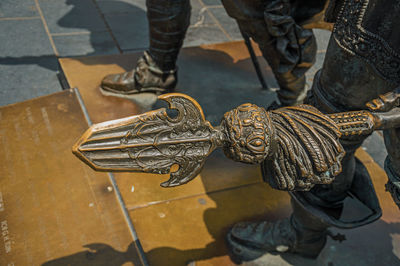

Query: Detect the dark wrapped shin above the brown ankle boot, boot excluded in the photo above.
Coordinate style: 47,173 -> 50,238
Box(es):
146,0 -> 191,71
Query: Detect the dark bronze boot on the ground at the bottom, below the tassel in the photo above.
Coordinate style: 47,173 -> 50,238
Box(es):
227,200 -> 328,263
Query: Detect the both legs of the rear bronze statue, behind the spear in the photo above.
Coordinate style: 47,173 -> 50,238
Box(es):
101,0 -> 316,105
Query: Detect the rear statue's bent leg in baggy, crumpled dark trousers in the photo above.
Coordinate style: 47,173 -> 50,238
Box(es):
222,0 -> 317,105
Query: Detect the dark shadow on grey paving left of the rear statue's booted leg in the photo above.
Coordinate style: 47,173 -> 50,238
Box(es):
57,0 -> 149,56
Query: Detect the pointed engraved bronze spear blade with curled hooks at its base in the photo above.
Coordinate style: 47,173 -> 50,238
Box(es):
73,93 -> 222,187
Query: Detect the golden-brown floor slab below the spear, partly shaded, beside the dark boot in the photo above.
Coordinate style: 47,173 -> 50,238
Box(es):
130,183 -> 290,266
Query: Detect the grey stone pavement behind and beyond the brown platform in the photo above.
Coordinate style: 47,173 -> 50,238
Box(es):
0,0 -> 394,264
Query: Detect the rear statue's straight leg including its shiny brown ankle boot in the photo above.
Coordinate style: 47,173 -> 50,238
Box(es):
100,0 -> 191,95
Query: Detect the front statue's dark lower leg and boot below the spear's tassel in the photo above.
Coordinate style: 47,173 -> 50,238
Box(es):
227,141 -> 359,262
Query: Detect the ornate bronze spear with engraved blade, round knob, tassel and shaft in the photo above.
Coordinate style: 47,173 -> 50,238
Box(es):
73,93 -> 400,190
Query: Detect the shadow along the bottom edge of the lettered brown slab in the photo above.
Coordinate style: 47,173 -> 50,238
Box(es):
42,242 -> 141,266
